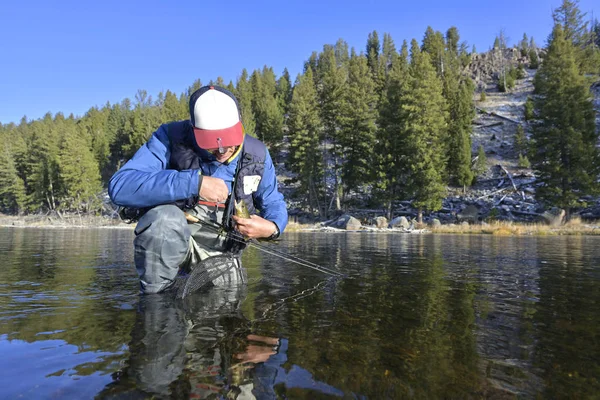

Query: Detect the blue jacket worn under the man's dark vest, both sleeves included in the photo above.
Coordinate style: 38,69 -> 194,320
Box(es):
108,121 -> 288,232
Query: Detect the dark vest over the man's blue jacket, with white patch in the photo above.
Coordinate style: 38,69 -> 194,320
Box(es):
166,121 -> 267,213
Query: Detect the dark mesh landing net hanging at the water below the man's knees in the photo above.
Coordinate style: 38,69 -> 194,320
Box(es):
167,255 -> 237,299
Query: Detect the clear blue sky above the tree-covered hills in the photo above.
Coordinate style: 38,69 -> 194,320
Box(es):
0,0 -> 600,123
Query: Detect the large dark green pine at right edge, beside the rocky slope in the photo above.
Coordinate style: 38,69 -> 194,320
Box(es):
531,24 -> 600,213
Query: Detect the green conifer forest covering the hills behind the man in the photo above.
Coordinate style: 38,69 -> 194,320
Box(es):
0,0 -> 600,220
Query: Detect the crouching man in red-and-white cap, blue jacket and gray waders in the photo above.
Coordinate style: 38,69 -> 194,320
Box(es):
108,86 -> 287,293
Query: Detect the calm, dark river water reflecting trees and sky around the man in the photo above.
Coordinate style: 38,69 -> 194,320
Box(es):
0,228 -> 600,399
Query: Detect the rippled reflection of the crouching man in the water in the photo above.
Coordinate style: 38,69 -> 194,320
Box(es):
97,286 -> 343,399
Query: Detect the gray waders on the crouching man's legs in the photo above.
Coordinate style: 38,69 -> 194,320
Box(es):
133,205 -> 246,293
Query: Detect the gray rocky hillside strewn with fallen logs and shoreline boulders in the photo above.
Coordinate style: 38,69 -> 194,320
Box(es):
308,63 -> 600,227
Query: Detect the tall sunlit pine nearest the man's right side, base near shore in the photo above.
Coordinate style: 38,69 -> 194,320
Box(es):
287,68 -> 325,216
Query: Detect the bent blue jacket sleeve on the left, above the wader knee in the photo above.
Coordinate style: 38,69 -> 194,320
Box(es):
108,125 -> 199,208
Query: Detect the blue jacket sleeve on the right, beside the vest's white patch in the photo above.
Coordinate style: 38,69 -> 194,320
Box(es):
255,151 -> 288,233
